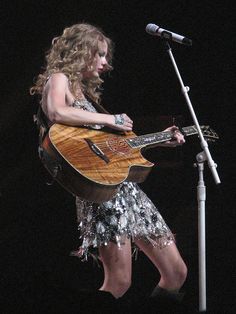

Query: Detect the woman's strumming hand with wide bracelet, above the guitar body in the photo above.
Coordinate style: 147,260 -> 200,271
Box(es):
106,113 -> 133,131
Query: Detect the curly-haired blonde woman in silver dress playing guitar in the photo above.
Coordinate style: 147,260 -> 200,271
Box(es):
31,23 -> 187,298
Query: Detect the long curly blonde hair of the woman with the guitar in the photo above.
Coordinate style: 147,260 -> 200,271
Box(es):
30,23 -> 113,103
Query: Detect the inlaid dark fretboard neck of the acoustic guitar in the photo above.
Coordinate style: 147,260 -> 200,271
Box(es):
126,125 -> 198,148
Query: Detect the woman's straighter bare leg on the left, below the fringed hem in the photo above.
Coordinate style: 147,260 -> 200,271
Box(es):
99,239 -> 132,298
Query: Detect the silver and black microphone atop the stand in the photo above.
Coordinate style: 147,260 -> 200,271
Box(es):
146,24 -> 192,46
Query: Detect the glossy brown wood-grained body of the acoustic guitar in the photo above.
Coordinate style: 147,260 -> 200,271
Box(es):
42,124 -> 153,203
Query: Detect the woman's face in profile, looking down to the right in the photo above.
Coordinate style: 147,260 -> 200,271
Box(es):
83,41 -> 108,78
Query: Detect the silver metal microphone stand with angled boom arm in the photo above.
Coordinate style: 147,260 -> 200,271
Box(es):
165,40 -> 220,312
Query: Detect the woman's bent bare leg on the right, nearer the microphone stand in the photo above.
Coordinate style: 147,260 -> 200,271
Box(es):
135,240 -> 187,291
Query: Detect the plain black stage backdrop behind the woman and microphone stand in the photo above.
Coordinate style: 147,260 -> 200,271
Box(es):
0,0 -> 236,313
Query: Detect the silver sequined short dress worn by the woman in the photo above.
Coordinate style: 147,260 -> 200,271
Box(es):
72,100 -> 174,260
